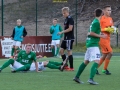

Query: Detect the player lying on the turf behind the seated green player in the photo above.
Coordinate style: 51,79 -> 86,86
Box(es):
10,55 -> 68,71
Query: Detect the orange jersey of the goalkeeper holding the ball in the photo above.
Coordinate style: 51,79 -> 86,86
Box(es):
100,15 -> 113,43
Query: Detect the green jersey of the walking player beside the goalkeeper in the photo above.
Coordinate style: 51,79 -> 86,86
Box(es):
86,18 -> 101,48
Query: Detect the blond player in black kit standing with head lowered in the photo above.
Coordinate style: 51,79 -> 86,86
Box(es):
58,7 -> 74,71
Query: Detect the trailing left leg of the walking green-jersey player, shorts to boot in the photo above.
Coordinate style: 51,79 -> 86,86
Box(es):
73,49 -> 90,83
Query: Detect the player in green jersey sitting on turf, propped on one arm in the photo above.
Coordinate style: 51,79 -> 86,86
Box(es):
0,44 -> 39,73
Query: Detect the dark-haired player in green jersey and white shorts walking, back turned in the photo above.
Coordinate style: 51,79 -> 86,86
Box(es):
73,8 -> 106,85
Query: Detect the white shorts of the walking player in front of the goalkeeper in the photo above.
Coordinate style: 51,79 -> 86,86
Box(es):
84,47 -> 101,61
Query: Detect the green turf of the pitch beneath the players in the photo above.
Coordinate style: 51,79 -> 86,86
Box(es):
0,57 -> 120,90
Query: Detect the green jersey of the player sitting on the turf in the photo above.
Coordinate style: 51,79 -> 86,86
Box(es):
17,50 -> 36,65
